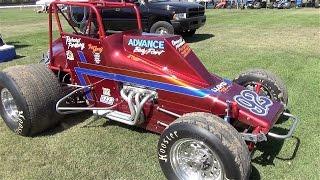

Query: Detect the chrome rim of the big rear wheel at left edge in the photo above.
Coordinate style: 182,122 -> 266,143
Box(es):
1,88 -> 20,123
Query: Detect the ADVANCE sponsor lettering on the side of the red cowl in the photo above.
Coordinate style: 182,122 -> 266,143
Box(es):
128,39 -> 165,56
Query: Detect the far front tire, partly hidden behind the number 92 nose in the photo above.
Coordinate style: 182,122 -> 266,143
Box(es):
233,69 -> 288,106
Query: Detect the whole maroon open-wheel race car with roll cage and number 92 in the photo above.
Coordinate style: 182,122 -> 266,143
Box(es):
0,1 -> 298,180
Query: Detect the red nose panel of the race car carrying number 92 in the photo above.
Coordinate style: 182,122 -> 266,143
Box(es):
211,82 -> 284,131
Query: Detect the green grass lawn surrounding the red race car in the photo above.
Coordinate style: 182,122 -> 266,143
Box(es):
0,9 -> 320,179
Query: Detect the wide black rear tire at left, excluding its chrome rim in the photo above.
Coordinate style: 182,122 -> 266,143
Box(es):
0,64 -> 65,136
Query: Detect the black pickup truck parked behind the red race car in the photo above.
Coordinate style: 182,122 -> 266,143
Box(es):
102,0 -> 206,36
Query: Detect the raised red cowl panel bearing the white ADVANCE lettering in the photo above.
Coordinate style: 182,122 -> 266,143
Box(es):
123,34 -> 213,88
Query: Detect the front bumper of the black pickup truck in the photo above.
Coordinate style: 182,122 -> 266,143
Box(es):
171,16 -> 206,32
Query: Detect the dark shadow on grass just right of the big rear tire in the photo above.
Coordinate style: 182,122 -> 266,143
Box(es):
37,111 -> 92,137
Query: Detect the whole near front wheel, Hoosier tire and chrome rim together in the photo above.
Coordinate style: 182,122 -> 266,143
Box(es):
158,113 -> 251,180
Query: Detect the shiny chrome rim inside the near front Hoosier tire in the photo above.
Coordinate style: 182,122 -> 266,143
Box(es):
170,138 -> 225,180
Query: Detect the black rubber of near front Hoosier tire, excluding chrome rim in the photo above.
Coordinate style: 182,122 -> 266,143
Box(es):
158,113 -> 251,180
